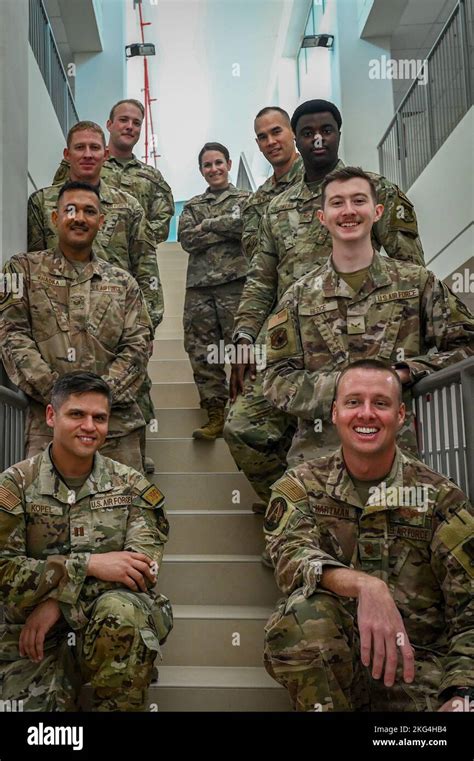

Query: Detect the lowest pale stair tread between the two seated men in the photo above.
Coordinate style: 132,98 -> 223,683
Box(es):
156,666 -> 283,690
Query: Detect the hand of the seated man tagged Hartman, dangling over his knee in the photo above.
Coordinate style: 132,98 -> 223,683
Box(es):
357,574 -> 415,687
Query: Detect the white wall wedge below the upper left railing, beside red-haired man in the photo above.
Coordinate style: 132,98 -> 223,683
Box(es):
28,45 -> 66,194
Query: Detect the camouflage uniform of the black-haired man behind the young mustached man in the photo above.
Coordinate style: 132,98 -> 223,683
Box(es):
224,161 -> 424,502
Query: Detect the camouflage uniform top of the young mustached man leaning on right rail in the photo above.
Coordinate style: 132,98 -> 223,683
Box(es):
263,254 -> 474,465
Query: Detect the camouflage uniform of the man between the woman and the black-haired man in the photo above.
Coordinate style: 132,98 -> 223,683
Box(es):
242,156 -> 304,262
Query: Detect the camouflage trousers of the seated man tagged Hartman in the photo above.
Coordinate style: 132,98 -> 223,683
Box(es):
264,590 -> 443,712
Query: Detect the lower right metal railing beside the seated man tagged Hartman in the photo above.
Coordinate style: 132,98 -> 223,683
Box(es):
412,357 -> 474,499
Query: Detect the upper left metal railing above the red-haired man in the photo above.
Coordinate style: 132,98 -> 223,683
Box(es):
28,0 -> 79,136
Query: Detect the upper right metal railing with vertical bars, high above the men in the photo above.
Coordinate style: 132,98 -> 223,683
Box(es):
377,0 -> 474,190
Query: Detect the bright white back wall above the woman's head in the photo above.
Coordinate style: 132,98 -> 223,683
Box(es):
127,0 -> 284,200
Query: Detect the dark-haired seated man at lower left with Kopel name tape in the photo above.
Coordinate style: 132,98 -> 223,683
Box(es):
0,372 -> 172,711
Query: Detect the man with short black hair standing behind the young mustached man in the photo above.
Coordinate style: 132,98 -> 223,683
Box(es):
224,99 -> 424,503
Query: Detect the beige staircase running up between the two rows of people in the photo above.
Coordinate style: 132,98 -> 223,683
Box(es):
148,243 -> 290,712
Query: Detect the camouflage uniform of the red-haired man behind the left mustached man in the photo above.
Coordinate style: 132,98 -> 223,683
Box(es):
28,180 -> 164,423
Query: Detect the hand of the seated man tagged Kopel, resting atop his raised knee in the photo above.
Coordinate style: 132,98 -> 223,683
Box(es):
87,550 -> 156,592
